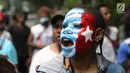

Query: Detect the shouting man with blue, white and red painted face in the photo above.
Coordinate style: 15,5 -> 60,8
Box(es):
36,7 -> 124,73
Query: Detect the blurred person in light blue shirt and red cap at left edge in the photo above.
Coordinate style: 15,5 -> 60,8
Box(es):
0,12 -> 18,65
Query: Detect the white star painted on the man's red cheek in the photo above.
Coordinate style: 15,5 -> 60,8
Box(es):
81,26 -> 93,42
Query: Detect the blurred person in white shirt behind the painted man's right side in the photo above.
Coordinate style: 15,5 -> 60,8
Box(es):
96,4 -> 118,63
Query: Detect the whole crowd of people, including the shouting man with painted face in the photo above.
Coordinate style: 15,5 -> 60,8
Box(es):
0,4 -> 130,73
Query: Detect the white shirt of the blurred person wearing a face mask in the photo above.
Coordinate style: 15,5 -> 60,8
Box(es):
31,24 -> 53,46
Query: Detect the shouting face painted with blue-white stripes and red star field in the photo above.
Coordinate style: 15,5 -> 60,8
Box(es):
60,8 -> 95,57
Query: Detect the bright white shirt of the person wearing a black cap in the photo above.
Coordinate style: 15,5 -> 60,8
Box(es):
29,46 -> 58,73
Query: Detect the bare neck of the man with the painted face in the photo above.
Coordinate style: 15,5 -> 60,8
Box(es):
72,50 -> 97,73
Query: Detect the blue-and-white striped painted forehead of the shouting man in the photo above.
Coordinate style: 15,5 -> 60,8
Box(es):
63,8 -> 84,25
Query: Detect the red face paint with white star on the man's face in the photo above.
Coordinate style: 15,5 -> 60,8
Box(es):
76,12 -> 96,56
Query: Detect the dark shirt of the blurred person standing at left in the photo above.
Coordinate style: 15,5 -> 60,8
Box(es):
9,25 -> 30,56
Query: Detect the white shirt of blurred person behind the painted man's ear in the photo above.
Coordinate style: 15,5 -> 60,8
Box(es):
96,26 -> 118,63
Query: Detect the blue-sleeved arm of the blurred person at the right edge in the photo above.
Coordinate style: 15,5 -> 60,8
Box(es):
117,42 -> 129,64
